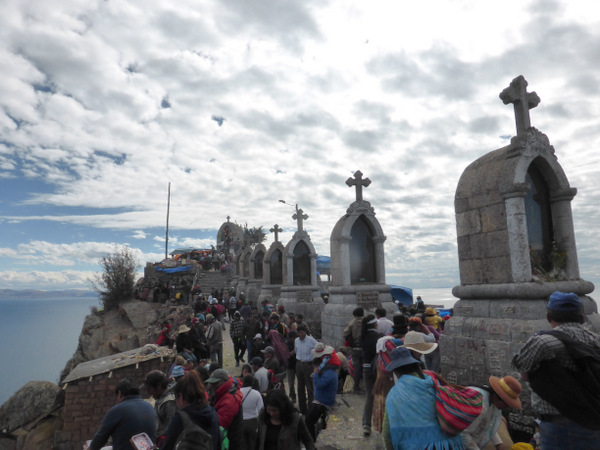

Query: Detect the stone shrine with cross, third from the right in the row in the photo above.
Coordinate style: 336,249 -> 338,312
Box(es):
271,205 -> 324,337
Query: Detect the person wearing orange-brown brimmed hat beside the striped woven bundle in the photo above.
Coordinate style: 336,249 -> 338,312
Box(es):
460,376 -> 521,450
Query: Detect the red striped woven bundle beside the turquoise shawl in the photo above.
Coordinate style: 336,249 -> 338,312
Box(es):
432,370 -> 483,436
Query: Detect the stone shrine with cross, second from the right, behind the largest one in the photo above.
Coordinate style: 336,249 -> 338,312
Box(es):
321,171 -> 398,347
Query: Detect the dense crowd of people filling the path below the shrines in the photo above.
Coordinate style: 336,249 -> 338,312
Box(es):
84,292 -> 600,450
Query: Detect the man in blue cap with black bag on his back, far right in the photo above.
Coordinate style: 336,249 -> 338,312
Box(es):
512,292 -> 600,450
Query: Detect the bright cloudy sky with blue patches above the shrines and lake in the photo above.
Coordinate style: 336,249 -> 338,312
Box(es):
0,0 -> 600,290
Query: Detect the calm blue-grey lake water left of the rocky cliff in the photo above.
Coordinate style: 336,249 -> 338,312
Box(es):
0,297 -> 98,405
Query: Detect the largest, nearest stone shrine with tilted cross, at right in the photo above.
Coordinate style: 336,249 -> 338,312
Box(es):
440,76 -> 600,411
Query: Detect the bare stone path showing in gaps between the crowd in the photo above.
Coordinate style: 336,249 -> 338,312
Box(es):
218,324 -> 384,450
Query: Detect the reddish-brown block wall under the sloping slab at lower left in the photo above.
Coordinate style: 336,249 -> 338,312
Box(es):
54,358 -> 170,450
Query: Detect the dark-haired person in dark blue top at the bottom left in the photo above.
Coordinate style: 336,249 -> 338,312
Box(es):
87,378 -> 156,450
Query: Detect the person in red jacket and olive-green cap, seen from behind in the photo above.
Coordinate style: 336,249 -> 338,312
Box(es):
206,369 -> 246,450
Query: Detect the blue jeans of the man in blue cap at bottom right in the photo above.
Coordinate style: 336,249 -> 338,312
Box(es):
540,417 -> 600,450
